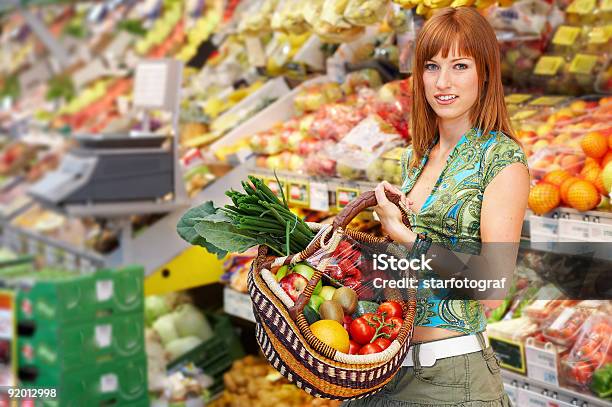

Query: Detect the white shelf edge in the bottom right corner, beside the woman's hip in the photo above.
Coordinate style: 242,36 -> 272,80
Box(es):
502,369 -> 612,407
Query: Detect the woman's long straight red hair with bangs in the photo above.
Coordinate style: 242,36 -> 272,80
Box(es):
410,7 -> 516,166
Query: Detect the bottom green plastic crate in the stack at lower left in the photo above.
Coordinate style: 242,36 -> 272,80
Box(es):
20,354 -> 148,407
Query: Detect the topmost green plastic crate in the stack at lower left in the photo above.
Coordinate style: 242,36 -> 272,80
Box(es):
17,266 -> 144,323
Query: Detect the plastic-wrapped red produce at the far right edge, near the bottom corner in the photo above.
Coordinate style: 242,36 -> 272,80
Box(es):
561,313 -> 612,388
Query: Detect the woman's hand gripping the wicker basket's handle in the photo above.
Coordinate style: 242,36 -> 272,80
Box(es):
374,181 -> 416,243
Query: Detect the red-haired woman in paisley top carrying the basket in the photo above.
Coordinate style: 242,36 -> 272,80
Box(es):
349,8 -> 529,406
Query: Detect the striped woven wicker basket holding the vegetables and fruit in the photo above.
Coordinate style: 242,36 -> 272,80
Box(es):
248,191 -> 416,400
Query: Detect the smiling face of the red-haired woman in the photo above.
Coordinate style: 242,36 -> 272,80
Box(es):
423,47 -> 478,124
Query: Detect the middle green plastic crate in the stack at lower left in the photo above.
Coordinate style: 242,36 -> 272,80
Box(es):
17,312 -> 145,370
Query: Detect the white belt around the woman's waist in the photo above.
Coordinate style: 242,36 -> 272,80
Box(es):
402,332 -> 489,367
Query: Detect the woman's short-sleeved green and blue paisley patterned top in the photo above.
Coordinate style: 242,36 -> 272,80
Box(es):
401,129 -> 527,334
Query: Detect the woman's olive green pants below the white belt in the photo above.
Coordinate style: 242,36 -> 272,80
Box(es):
343,334 -> 512,407
